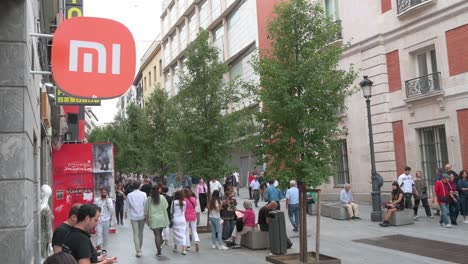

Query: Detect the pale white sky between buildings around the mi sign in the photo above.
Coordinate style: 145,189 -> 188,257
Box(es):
83,0 -> 162,124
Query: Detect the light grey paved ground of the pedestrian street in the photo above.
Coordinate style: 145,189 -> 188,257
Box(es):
98,188 -> 468,264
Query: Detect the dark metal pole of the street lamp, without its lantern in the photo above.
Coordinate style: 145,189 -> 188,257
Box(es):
366,97 -> 382,222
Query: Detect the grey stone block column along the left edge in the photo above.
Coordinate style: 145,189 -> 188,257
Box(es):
0,0 -> 41,263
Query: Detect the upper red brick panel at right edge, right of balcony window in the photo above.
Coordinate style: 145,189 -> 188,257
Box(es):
445,24 -> 468,76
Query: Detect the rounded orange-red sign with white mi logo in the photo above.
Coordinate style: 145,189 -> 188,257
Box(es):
52,17 -> 136,99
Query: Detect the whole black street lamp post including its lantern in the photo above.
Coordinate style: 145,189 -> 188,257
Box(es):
359,76 -> 383,222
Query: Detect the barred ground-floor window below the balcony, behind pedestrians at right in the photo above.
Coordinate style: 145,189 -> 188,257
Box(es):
418,125 -> 449,193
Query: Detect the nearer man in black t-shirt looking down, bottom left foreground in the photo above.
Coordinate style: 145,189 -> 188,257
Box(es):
64,204 -> 117,264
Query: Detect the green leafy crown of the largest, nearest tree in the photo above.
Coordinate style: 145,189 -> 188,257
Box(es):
253,0 -> 355,186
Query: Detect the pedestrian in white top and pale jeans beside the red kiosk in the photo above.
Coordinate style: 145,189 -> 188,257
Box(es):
94,188 -> 114,250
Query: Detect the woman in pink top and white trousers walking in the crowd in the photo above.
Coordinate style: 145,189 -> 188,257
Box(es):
184,188 -> 200,253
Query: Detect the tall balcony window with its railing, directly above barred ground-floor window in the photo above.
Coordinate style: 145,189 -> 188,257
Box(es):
405,48 -> 441,98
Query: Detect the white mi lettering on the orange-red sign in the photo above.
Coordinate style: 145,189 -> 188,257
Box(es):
68,40 -> 120,74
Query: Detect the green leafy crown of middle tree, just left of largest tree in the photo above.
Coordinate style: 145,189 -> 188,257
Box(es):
170,30 -> 245,180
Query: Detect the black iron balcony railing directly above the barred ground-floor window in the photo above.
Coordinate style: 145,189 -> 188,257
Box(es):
405,72 -> 440,98
